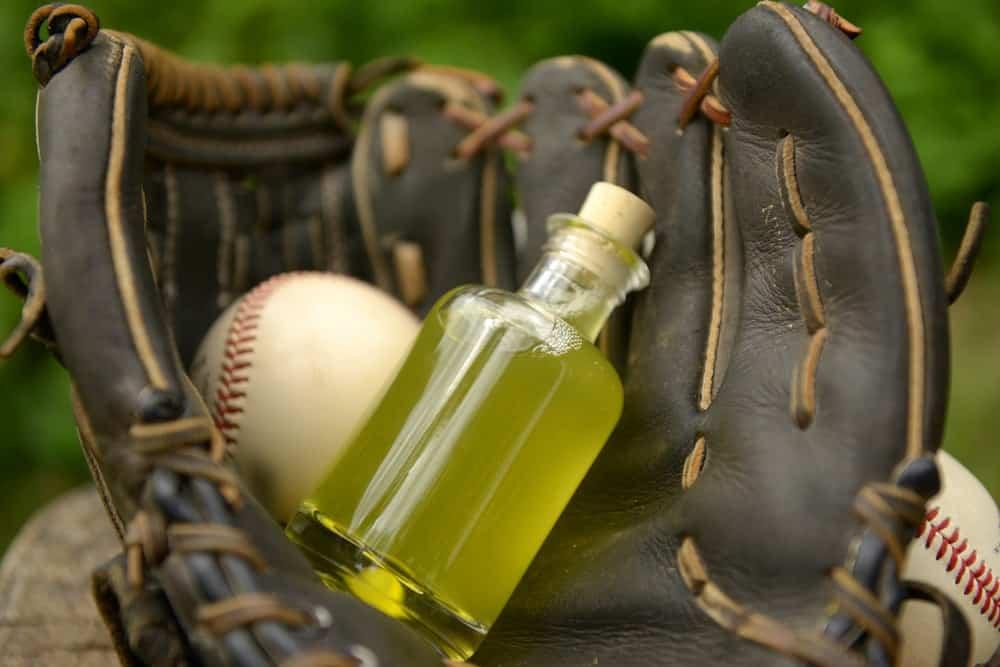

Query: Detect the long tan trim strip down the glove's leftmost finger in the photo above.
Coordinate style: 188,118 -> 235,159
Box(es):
104,44 -> 169,389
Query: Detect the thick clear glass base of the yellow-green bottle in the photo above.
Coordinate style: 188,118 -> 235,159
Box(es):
285,504 -> 487,660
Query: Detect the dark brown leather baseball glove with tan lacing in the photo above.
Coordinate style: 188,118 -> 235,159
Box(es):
0,2 -> 985,667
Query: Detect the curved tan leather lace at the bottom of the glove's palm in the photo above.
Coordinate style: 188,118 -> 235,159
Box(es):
677,537 -> 862,667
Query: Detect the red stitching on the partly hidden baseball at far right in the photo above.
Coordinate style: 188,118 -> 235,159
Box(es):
916,507 -> 1000,630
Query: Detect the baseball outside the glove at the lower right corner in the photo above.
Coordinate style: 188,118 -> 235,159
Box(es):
899,451 -> 1000,667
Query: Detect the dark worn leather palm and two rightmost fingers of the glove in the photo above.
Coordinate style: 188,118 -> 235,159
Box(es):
474,3 -> 948,667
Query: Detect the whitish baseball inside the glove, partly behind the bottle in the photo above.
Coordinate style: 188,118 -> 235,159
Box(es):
191,272 -> 419,521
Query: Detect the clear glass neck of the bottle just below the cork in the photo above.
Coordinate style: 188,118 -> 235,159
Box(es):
518,215 -> 649,342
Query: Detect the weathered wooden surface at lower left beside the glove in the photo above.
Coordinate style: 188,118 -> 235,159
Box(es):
0,486 -> 121,667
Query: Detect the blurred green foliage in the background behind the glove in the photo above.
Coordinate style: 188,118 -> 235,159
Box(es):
0,0 -> 1000,551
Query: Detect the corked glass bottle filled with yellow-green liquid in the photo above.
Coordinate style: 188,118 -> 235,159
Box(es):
286,183 -> 653,659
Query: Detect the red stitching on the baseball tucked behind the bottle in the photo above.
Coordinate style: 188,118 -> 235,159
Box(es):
212,271 -> 310,446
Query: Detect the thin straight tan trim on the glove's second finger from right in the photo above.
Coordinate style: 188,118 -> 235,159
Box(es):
698,126 -> 726,410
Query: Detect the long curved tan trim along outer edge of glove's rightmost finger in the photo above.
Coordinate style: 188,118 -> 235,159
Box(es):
760,0 -> 926,458
